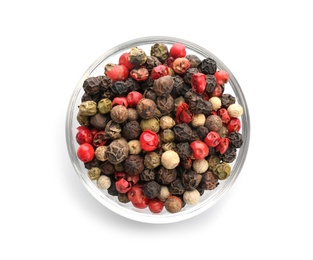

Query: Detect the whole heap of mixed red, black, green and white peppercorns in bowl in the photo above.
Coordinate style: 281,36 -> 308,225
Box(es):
76,43 -> 243,213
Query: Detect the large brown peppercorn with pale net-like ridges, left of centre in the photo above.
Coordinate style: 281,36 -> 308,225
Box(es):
107,138 -> 129,164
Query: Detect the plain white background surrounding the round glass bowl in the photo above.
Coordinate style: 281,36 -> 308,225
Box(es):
0,0 -> 313,260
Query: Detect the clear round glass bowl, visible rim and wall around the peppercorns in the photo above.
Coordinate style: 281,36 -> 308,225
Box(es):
66,36 -> 250,224
